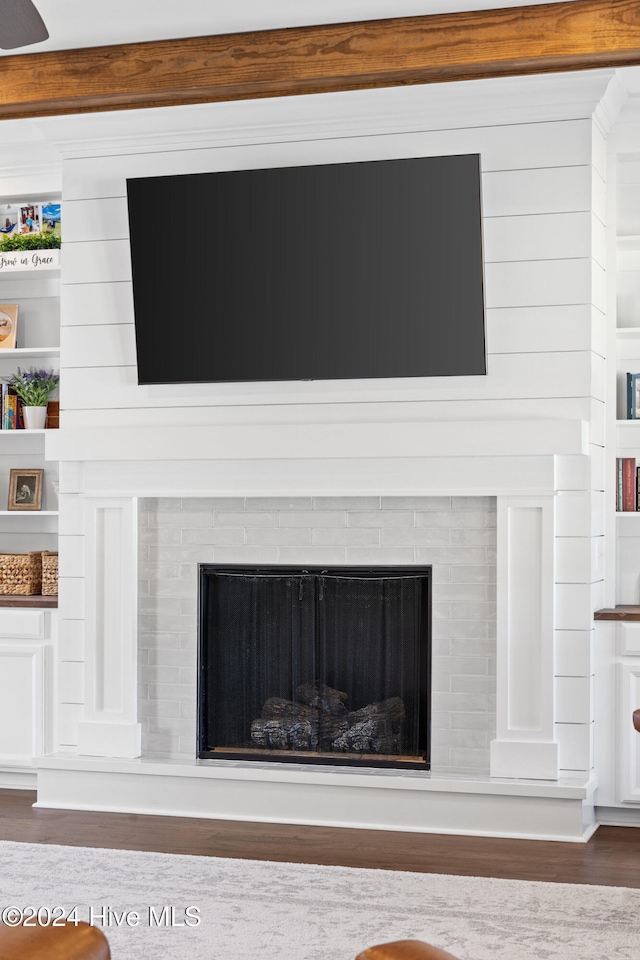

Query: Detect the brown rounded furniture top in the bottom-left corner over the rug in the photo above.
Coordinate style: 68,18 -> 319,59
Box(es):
0,921 -> 111,960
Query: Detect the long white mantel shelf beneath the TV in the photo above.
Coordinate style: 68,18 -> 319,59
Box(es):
46,420 -> 588,462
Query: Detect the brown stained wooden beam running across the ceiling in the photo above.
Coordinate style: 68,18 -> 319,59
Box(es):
0,0 -> 640,119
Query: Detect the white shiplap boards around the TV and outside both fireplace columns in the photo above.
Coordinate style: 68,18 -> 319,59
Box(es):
53,77 -> 605,770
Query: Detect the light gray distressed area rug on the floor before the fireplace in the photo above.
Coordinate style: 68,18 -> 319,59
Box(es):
0,841 -> 640,960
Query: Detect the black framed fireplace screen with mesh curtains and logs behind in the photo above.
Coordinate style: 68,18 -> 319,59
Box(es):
198,564 -> 431,769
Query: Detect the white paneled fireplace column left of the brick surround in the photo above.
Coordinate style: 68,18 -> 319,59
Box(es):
78,497 -> 141,758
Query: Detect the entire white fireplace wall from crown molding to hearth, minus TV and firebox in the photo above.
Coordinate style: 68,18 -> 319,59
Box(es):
23,63 -> 617,841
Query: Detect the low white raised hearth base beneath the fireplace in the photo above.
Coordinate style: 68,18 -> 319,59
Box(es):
36,757 -> 595,842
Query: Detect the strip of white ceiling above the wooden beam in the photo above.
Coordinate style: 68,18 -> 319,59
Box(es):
0,0 -> 567,56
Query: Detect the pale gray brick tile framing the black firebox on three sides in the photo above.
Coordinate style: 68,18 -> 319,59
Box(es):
138,496 -> 496,774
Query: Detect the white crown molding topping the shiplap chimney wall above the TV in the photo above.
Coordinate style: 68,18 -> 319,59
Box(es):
28,70 -> 622,158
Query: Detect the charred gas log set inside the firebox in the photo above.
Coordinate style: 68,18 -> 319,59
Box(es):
251,682 -> 405,756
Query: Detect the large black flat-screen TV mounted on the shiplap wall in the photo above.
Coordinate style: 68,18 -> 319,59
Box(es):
127,154 -> 486,384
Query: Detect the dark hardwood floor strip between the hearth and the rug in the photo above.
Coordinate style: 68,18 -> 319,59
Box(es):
0,790 -> 640,888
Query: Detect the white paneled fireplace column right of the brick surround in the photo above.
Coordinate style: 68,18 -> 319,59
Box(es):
491,496 -> 558,780
